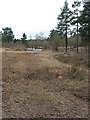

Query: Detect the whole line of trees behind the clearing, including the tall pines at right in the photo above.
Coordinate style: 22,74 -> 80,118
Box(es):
2,0 -> 90,52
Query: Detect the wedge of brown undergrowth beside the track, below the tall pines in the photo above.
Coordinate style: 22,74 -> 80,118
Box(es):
55,50 -> 88,68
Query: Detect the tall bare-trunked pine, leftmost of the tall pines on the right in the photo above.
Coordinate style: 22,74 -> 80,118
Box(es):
57,0 -> 72,52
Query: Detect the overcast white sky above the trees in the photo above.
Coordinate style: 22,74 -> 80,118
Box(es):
0,0 -> 83,38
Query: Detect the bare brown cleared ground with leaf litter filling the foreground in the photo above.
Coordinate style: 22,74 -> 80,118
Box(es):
2,50 -> 88,118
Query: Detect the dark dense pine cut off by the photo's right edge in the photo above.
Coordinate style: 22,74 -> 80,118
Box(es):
79,1 -> 90,46
